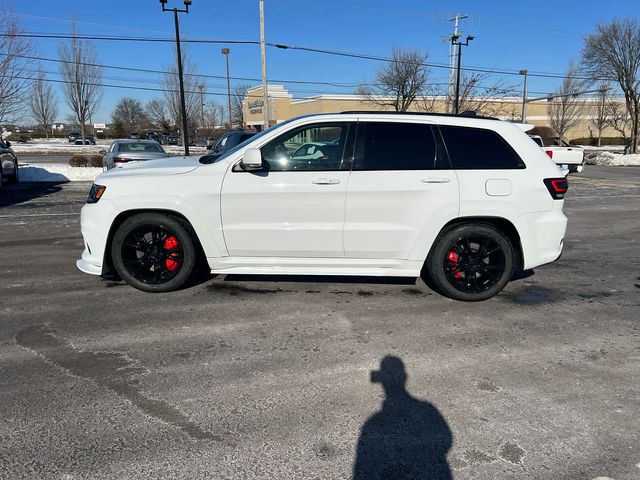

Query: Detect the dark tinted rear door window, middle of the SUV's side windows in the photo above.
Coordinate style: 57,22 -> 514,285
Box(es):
354,122 -> 436,170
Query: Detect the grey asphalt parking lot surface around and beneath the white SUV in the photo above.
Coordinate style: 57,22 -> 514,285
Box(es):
0,167 -> 640,480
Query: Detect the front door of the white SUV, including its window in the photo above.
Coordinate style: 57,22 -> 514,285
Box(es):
222,123 -> 355,257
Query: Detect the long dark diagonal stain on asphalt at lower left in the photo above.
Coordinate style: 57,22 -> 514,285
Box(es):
16,325 -> 223,442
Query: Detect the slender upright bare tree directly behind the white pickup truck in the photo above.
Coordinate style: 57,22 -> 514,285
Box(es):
547,61 -> 583,145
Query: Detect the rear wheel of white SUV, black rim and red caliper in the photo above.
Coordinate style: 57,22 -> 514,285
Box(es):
423,223 -> 515,302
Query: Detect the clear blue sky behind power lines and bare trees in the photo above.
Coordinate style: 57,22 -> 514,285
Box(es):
6,0 -> 640,123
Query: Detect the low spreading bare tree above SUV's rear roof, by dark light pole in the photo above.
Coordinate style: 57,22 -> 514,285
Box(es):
448,73 -> 515,117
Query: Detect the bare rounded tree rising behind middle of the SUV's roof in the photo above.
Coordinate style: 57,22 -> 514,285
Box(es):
357,48 -> 429,112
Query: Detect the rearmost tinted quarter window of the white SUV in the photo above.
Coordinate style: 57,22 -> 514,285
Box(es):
440,125 -> 525,170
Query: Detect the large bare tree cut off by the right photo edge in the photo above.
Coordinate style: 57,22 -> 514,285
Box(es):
582,18 -> 640,153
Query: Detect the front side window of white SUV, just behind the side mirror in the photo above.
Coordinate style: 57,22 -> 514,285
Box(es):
261,124 -> 349,172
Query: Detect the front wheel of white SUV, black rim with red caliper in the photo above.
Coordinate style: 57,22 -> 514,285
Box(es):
111,213 -> 197,292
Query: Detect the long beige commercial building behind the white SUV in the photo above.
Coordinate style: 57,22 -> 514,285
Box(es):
243,85 -> 620,140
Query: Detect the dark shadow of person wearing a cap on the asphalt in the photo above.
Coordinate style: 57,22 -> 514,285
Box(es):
353,356 -> 453,480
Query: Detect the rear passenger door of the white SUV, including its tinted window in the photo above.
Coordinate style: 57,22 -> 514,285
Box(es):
344,122 -> 459,259
